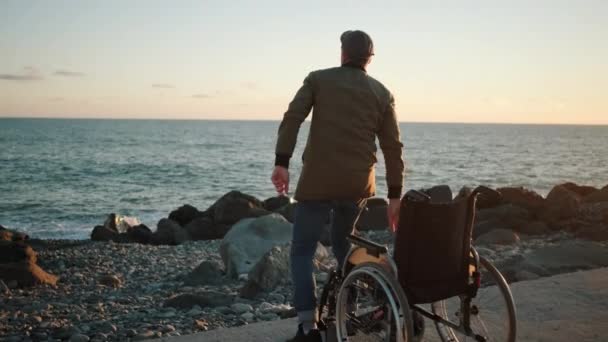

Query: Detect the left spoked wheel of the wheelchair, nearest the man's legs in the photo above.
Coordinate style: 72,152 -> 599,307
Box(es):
336,263 -> 413,342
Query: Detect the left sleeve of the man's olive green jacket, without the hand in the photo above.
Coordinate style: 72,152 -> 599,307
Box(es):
275,73 -> 314,167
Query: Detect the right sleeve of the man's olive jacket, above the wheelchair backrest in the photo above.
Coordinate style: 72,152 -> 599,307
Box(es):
378,94 -> 404,198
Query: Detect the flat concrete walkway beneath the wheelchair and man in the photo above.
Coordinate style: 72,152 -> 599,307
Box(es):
164,268 -> 608,342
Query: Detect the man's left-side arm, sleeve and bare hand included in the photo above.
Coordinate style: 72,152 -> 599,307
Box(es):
271,73 -> 313,194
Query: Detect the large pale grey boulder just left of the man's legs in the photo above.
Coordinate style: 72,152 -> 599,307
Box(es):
220,214 -> 293,279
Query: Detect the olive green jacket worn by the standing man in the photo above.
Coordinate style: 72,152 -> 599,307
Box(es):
275,65 -> 404,201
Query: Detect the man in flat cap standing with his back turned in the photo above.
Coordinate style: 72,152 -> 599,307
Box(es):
271,31 -> 403,342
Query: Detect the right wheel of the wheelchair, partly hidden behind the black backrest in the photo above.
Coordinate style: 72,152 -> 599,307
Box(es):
431,257 -> 516,342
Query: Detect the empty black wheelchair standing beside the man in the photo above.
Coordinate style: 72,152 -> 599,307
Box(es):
318,187 -> 516,342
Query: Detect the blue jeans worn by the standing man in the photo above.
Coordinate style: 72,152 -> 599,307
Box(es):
291,201 -> 364,322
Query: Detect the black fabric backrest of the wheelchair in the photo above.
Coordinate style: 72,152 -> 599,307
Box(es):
394,189 -> 476,304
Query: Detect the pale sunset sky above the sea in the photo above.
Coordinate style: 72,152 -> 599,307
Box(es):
0,0 -> 608,124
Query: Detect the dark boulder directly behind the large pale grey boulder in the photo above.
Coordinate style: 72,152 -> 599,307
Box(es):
209,191 -> 270,225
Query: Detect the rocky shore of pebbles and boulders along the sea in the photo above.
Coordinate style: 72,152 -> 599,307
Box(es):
0,183 -> 608,341
